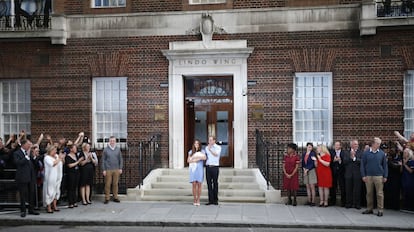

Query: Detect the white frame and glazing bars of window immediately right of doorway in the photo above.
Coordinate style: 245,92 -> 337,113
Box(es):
292,72 -> 333,146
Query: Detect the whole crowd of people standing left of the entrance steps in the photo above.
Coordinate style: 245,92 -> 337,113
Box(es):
0,131 -> 123,217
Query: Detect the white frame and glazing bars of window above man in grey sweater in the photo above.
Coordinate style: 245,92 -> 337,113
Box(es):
91,77 -> 128,149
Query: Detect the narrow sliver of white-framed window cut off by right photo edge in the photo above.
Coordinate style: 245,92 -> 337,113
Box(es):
404,70 -> 414,138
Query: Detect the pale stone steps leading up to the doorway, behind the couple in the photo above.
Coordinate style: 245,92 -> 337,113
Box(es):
127,168 -> 280,203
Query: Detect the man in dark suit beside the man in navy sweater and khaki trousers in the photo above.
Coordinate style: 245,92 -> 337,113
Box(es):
344,140 -> 363,209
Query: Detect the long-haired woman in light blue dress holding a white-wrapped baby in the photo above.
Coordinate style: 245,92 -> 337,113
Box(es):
187,139 -> 206,206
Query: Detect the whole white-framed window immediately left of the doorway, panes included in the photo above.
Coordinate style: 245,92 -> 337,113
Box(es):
92,77 -> 128,148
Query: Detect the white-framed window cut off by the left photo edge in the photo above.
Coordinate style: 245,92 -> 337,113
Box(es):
0,80 -> 31,142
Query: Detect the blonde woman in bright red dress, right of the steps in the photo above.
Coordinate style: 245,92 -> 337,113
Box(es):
316,145 -> 332,207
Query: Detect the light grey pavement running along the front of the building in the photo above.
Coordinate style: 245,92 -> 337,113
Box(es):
0,200 -> 414,231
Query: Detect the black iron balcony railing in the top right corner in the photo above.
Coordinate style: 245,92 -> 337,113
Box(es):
376,0 -> 414,17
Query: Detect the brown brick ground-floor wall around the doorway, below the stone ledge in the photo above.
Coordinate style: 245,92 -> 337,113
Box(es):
0,27 -> 414,174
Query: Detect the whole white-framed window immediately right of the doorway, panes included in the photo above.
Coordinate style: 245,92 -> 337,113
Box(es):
293,72 -> 333,145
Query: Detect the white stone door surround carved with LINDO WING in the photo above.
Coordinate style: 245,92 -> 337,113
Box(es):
162,40 -> 253,169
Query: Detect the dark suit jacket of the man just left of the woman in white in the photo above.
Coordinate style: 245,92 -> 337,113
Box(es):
13,148 -> 36,184
